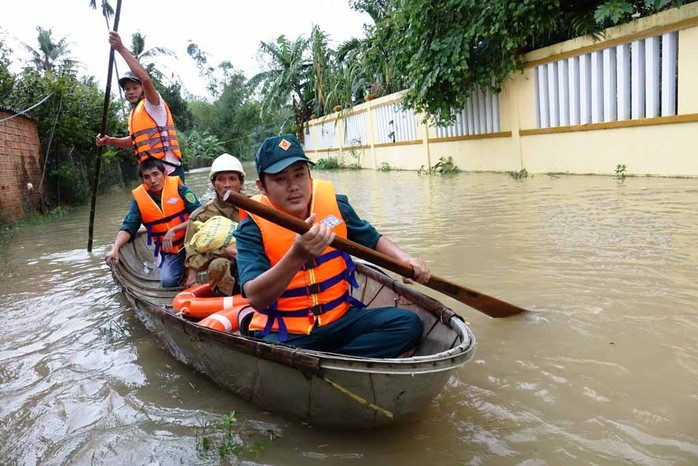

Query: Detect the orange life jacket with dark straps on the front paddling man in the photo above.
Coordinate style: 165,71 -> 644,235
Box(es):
241,180 -> 365,341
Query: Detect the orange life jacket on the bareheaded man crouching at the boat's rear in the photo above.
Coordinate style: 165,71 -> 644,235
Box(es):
131,176 -> 189,256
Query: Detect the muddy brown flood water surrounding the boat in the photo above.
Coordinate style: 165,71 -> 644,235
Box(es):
0,168 -> 698,465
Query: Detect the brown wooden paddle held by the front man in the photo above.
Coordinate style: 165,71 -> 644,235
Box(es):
224,191 -> 526,317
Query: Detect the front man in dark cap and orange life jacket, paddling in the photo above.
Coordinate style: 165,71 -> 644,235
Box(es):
234,134 -> 431,358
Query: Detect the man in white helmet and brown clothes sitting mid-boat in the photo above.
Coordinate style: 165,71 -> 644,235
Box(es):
184,154 -> 245,296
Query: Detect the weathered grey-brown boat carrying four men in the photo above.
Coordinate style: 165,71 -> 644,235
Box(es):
112,234 -> 475,429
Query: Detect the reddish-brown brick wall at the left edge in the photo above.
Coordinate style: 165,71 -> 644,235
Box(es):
0,108 -> 42,225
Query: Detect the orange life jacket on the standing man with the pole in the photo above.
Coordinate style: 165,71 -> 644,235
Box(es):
128,97 -> 182,165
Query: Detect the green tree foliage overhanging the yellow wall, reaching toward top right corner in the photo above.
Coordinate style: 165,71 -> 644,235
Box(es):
372,0 -> 688,124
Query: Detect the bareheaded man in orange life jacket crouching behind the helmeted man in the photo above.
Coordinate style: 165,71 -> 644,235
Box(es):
104,158 -> 201,288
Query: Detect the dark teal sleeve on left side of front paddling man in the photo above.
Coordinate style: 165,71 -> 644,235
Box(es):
233,216 -> 271,295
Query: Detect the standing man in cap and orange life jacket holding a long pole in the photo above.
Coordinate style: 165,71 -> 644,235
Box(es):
96,31 -> 184,183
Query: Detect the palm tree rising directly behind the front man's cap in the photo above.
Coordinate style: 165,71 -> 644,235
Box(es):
247,35 -> 312,142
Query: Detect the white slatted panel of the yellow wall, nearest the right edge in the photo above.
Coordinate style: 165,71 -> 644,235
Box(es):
535,32 -> 678,128
